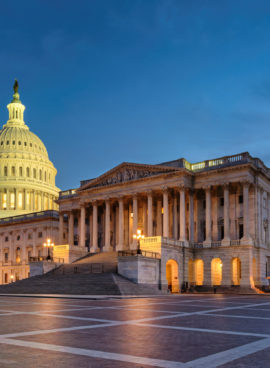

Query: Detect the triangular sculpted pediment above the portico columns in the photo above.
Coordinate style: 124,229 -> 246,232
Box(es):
79,162 -> 179,191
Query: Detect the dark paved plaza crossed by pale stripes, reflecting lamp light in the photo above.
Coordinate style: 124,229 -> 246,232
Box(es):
0,295 -> 270,368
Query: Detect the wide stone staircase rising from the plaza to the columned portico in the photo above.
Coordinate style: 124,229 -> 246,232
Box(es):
0,252 -> 162,296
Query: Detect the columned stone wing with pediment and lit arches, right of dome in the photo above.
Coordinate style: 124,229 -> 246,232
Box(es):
58,153 -> 270,290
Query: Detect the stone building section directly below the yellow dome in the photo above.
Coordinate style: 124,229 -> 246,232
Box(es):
0,211 -> 67,284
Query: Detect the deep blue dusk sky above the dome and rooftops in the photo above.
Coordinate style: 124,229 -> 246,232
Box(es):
0,0 -> 270,189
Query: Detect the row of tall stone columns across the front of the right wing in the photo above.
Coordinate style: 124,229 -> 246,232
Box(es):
59,182 -> 251,252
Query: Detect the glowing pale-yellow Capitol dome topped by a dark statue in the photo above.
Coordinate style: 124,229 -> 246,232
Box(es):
0,81 -> 59,218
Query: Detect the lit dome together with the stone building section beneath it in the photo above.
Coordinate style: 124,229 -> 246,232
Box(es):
0,81 -> 61,284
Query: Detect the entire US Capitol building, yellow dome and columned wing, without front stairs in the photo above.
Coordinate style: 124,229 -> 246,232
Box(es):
0,81 -> 270,292
